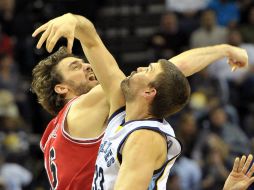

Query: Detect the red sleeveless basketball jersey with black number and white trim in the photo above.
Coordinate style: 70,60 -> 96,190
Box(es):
40,99 -> 103,190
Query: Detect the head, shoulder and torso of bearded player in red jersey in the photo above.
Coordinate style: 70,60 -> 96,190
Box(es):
32,47 -> 109,190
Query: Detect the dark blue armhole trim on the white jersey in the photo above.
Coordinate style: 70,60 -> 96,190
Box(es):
117,126 -> 182,175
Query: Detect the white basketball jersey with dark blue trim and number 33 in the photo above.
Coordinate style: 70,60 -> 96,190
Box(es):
92,108 -> 181,190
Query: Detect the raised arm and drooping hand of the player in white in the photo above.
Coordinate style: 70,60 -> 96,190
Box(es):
33,13 -> 125,113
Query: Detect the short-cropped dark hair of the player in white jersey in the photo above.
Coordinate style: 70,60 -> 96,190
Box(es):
149,59 -> 190,118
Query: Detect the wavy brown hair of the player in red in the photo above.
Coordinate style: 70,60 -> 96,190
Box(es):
31,47 -> 75,115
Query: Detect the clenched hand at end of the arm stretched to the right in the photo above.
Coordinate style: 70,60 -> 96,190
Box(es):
228,46 -> 248,71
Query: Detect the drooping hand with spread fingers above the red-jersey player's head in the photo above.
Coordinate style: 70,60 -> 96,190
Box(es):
32,13 -> 78,53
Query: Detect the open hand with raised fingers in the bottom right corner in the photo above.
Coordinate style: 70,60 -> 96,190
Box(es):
223,155 -> 254,190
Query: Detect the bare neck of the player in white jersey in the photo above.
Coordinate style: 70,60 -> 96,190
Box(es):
125,101 -> 152,122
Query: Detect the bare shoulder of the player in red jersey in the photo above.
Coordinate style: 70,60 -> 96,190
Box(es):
65,85 -> 109,138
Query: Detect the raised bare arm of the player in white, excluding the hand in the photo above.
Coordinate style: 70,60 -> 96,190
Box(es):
75,16 -> 125,115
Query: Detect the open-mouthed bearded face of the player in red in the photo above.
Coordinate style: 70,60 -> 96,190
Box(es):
57,57 -> 98,96
